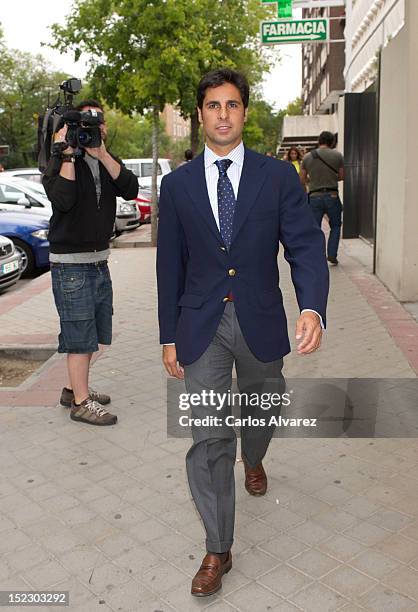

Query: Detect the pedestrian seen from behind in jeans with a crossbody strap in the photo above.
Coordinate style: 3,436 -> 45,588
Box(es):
300,132 -> 344,266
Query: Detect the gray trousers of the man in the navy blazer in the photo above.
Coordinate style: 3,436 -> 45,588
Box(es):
184,302 -> 285,553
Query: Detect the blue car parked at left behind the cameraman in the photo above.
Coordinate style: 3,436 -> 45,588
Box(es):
0,207 -> 49,276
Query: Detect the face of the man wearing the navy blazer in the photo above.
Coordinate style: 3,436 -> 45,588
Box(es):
198,83 -> 247,150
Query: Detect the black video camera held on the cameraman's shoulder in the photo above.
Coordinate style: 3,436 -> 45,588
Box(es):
38,79 -> 104,172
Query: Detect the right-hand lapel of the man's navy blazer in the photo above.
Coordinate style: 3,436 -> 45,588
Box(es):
231,148 -> 266,242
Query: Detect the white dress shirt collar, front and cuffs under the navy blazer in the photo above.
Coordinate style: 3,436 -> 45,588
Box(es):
165,141 -> 324,346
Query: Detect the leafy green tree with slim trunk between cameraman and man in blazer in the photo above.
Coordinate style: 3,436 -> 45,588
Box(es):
52,0 -> 217,245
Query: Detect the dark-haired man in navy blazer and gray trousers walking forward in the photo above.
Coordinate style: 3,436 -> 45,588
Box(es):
157,69 -> 329,596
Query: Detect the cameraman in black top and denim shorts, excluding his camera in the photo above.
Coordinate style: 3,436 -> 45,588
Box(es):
42,100 -> 138,425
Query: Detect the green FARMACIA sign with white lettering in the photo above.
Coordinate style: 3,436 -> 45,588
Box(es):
261,19 -> 329,45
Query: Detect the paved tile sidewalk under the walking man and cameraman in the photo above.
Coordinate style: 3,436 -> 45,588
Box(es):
0,242 -> 418,612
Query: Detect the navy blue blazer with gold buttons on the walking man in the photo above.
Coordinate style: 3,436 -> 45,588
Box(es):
157,148 -> 329,365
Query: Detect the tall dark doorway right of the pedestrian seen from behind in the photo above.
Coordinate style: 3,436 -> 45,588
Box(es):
343,86 -> 378,242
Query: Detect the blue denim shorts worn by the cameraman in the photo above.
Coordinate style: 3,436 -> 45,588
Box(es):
51,261 -> 113,353
